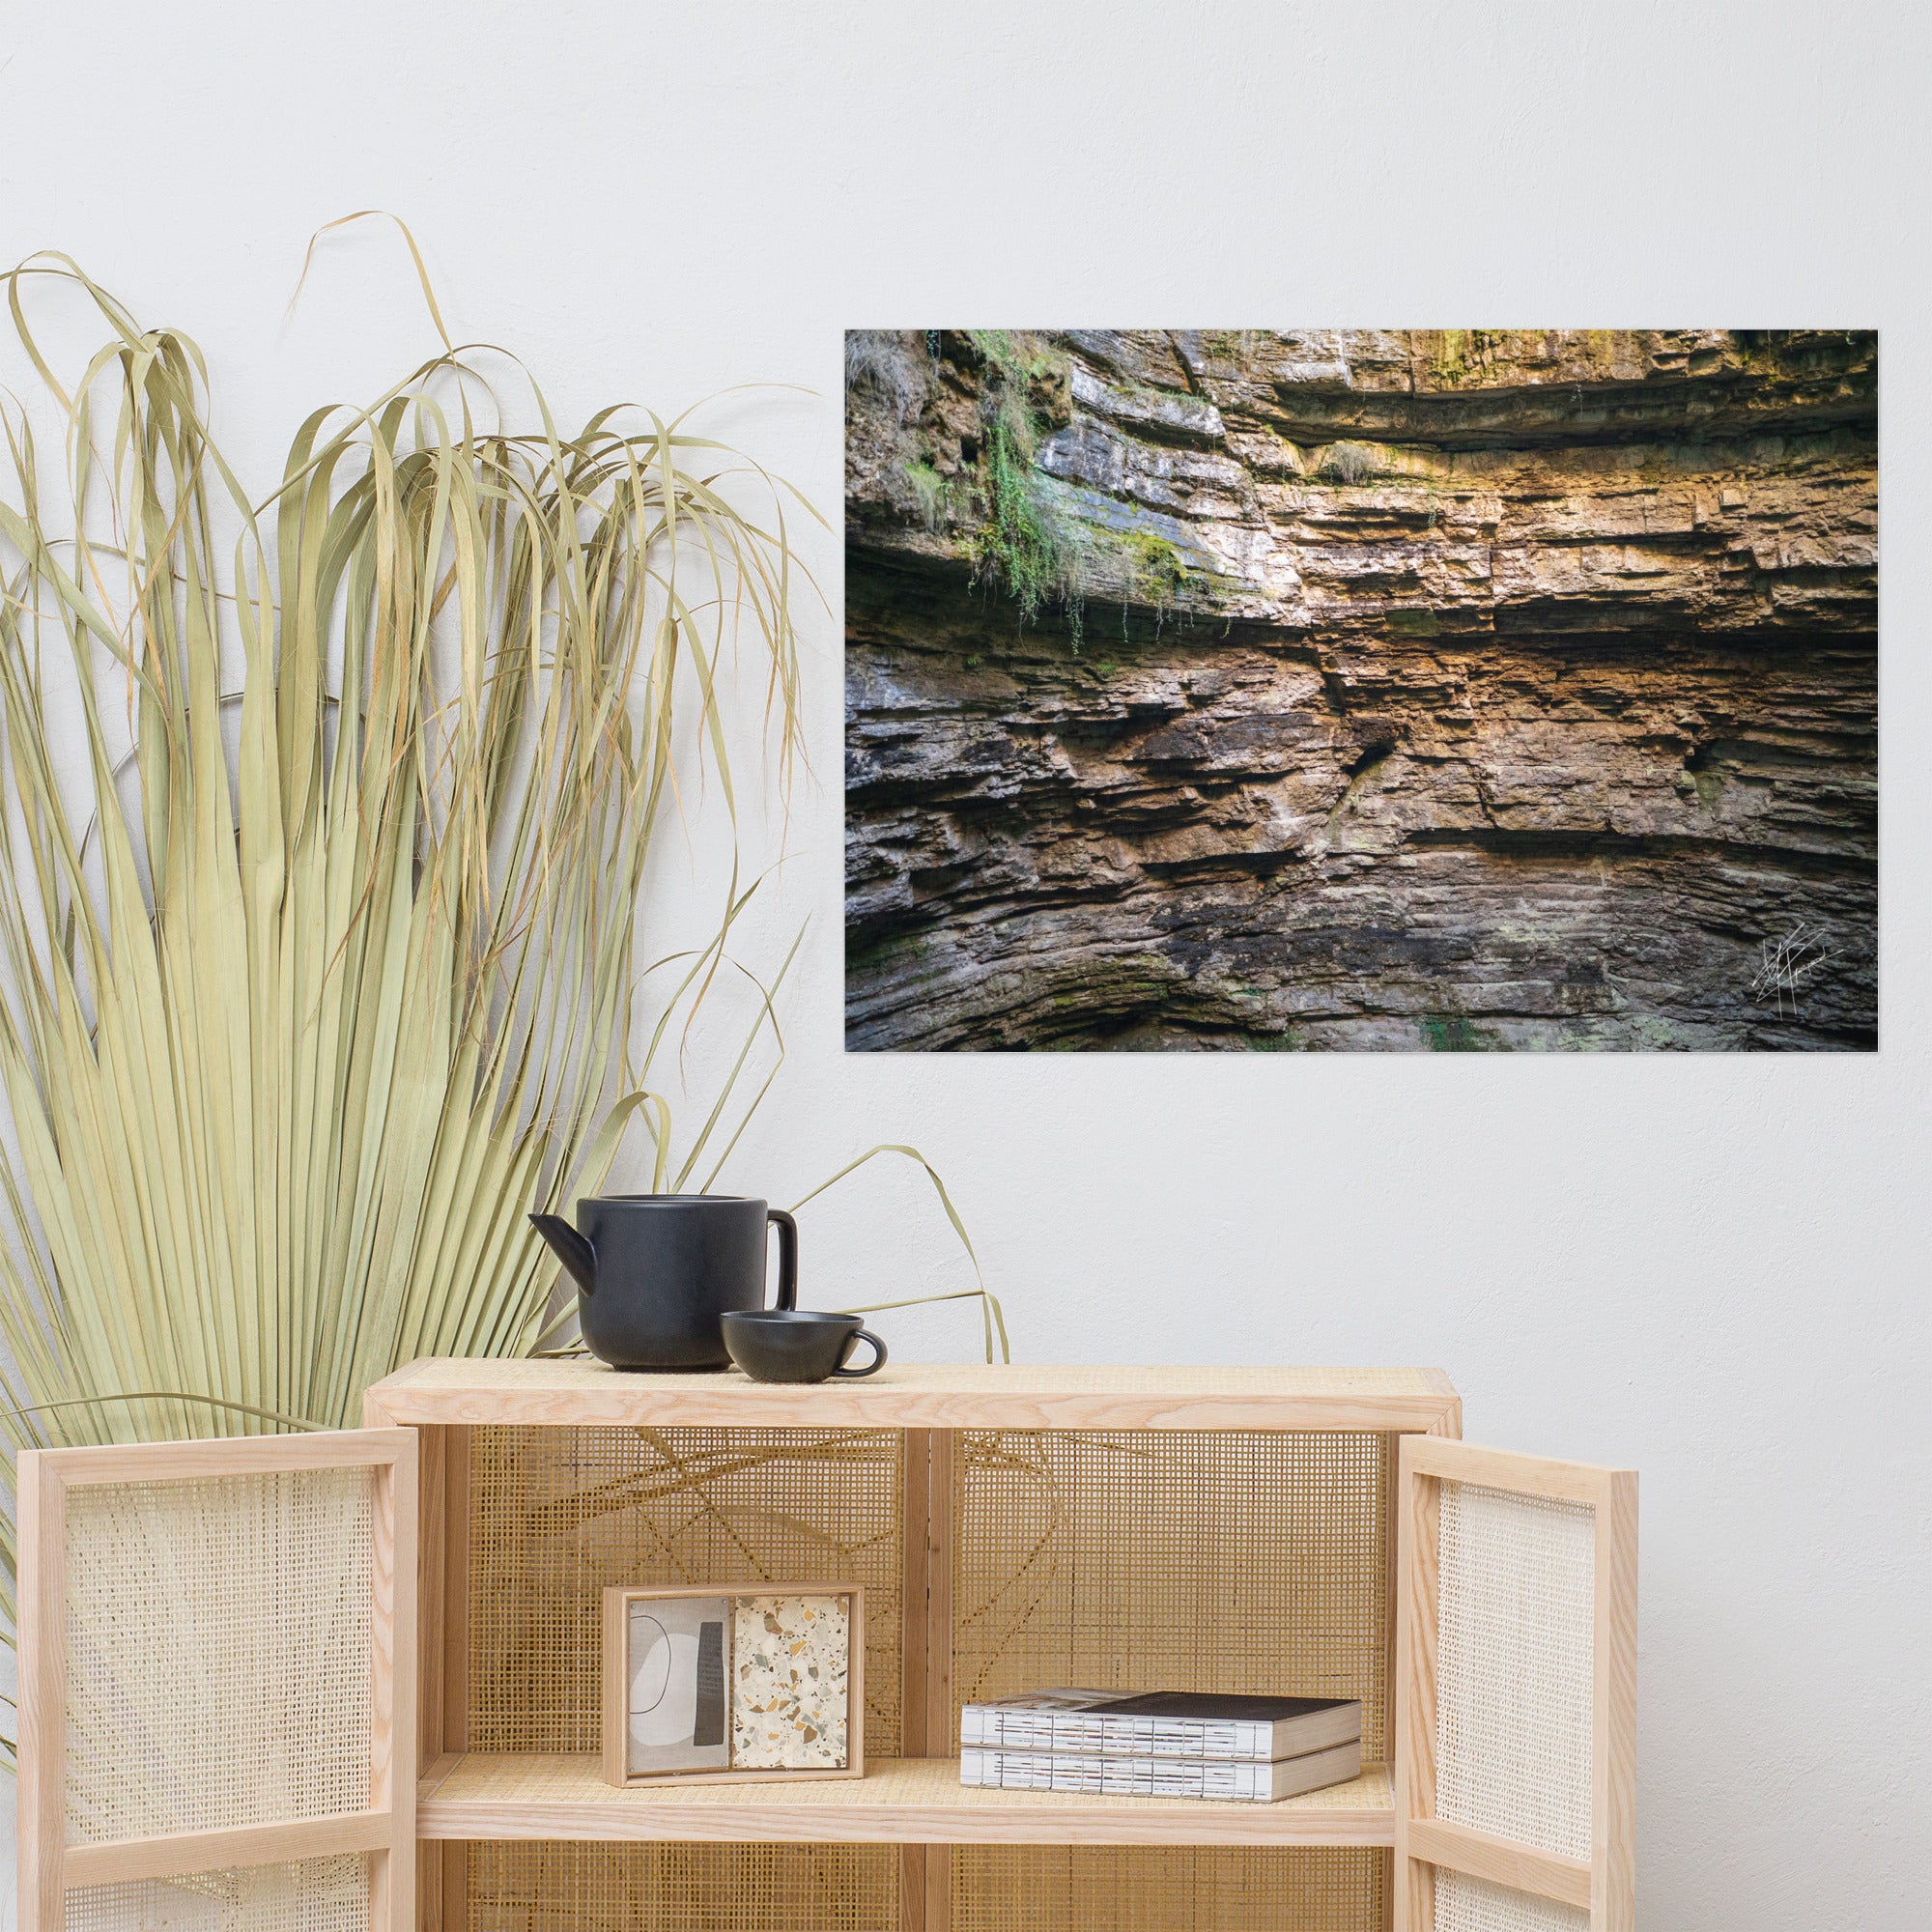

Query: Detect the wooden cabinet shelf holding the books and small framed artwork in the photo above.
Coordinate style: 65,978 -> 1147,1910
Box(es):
415,1754 -> 1395,1845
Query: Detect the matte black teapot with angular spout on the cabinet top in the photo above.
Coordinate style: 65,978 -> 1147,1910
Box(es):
529,1194 -> 798,1368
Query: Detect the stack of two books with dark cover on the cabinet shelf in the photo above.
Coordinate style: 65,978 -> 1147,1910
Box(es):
960,1690 -> 1362,1804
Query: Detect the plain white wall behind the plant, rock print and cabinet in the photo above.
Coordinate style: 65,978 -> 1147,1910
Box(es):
0,0 -> 1932,1932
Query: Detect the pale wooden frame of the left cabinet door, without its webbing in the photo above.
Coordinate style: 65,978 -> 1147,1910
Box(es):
17,1428 -> 417,1932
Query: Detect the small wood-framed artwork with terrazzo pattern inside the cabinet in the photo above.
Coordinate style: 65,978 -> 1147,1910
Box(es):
603,1582 -> 866,1785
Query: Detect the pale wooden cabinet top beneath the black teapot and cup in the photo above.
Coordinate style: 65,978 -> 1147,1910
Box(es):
367,1358 -> 1463,1435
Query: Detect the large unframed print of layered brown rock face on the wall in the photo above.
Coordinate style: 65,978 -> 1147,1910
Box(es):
846,330 -> 1878,1049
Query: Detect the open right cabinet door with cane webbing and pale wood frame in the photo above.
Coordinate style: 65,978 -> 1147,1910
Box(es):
1395,1435 -> 1636,1932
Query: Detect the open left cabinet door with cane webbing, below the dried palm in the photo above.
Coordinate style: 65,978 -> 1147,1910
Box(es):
19,1430 -> 417,1932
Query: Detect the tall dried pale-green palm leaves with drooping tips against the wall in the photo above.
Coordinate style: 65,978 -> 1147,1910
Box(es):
0,242 -> 993,1770
